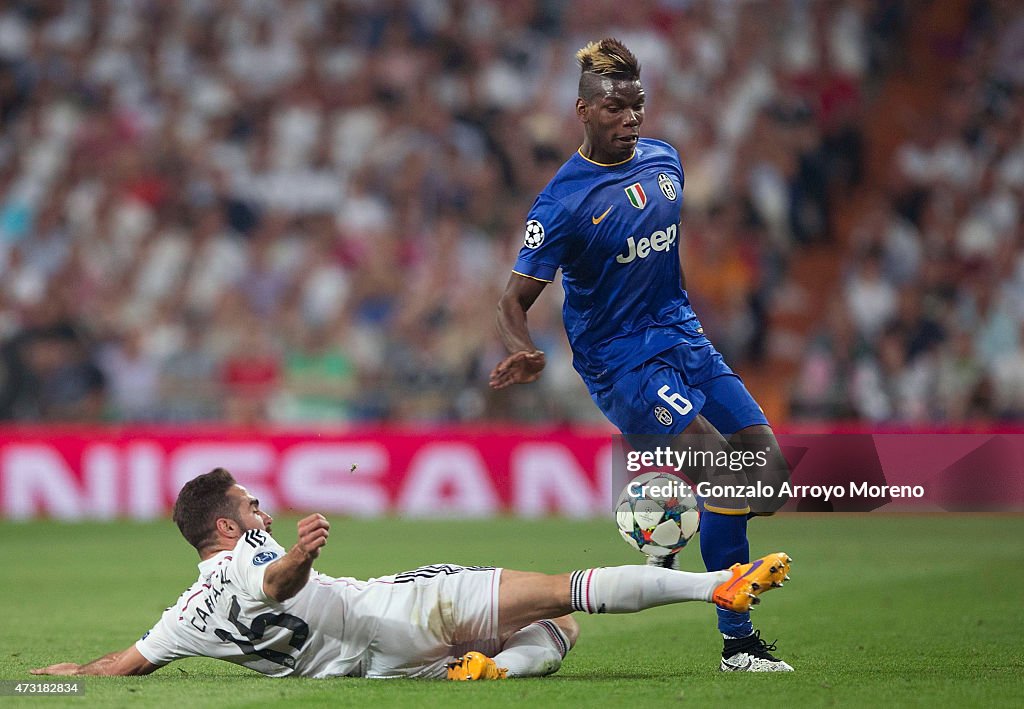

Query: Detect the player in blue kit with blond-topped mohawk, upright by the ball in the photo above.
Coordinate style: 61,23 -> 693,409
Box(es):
490,38 -> 793,672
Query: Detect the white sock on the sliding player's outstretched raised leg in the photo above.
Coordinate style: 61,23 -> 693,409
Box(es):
569,567 -> 732,613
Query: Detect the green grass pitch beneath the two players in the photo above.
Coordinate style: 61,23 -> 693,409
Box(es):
0,514 -> 1024,708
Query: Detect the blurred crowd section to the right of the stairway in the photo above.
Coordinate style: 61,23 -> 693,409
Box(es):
794,1 -> 1024,423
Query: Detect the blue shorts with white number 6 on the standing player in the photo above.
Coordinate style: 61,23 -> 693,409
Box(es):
592,334 -> 768,435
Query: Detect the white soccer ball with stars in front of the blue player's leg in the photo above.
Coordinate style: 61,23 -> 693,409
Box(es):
615,472 -> 700,556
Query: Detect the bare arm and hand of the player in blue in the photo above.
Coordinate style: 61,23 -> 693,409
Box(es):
490,274 -> 548,389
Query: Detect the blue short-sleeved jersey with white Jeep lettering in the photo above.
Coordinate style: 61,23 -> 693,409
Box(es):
514,138 -> 699,393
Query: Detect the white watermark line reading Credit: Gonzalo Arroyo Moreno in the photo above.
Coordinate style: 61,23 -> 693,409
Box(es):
627,481 -> 925,502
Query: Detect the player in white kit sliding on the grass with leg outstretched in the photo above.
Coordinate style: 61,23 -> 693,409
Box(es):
33,468 -> 791,679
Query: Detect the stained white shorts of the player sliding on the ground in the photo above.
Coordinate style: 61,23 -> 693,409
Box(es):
364,564 -> 502,678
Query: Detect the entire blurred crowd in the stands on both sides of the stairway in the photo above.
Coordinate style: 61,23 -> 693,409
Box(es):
0,0 -> 1024,424
